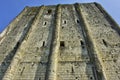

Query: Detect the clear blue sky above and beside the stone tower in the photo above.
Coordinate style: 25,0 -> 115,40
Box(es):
0,0 -> 120,32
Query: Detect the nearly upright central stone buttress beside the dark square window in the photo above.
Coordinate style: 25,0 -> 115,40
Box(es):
46,5 -> 61,80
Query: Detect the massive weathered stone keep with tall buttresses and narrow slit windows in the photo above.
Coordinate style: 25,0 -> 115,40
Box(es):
0,3 -> 120,80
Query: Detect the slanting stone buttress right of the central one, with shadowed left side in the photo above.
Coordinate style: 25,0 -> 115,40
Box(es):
75,4 -> 104,80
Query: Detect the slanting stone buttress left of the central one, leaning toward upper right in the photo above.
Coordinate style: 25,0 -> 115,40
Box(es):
3,6 -> 44,80
